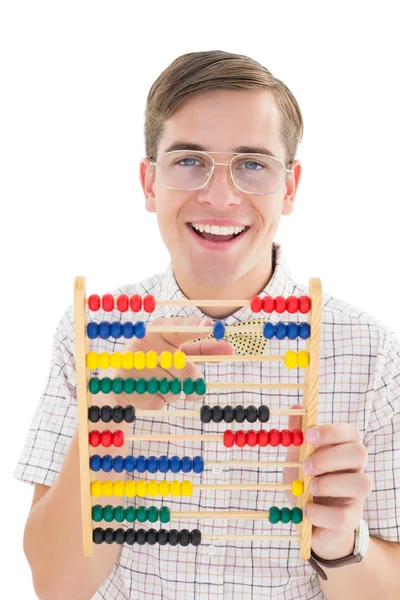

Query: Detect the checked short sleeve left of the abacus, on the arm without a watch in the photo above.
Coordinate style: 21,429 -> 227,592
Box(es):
13,306 -> 77,486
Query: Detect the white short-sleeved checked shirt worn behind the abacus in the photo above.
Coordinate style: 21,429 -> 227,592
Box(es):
14,244 -> 400,600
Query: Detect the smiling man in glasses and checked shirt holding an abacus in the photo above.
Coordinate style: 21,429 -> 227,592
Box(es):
15,51 -> 400,600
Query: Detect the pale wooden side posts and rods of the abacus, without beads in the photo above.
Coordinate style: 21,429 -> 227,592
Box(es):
74,276 -> 322,560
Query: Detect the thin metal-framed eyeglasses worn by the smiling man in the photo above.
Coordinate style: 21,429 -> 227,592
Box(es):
150,150 -> 293,194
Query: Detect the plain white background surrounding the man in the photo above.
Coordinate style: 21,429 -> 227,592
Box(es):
0,0 -> 400,600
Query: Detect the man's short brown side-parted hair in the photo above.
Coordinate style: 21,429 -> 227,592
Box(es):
144,50 -> 303,166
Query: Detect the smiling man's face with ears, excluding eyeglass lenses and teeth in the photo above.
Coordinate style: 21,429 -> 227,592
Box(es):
140,90 -> 301,288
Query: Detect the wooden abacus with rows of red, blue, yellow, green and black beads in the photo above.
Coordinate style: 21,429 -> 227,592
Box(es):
74,277 -> 322,560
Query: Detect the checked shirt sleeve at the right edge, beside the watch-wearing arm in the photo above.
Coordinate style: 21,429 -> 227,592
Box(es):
364,334 -> 400,542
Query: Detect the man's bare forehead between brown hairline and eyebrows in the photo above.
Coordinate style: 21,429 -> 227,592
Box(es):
159,90 -> 284,159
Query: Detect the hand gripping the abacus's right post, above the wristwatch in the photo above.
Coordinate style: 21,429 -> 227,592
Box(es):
283,404 -> 372,560
